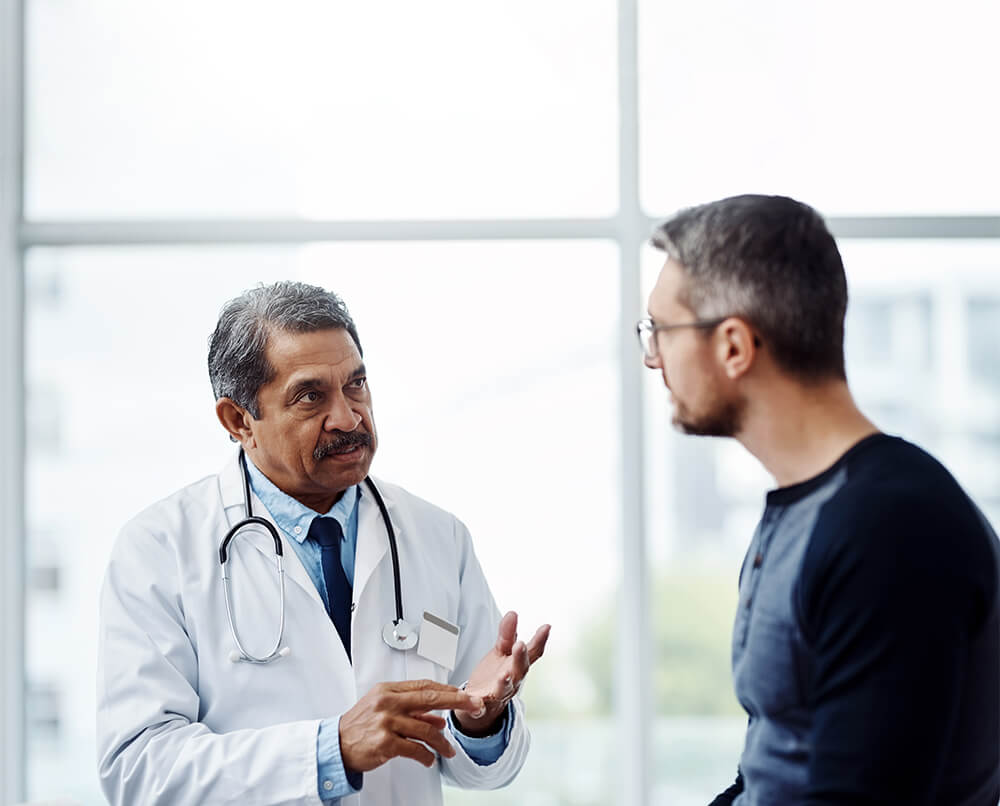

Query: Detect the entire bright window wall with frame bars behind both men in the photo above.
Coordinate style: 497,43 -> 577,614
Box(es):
0,0 -> 1000,806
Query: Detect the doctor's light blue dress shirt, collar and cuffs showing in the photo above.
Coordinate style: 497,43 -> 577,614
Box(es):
247,457 -> 514,800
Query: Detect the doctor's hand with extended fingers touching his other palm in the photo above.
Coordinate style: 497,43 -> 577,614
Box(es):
340,680 -> 485,772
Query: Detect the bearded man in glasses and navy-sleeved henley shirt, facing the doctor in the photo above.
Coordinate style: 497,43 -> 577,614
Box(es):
637,196 -> 1000,806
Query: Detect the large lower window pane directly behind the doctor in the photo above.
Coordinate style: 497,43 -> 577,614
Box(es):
27,242 -> 621,804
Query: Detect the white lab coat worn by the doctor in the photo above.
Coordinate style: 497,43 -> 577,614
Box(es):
97,458 -> 529,806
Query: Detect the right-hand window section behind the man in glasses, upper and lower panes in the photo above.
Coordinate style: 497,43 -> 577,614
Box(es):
639,0 -> 1000,806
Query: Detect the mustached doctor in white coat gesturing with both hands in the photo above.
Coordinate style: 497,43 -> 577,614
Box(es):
97,283 -> 549,806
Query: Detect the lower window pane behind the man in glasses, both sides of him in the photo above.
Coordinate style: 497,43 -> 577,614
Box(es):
636,241 -> 1000,806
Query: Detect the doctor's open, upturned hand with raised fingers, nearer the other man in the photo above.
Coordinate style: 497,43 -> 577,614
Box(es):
453,610 -> 551,736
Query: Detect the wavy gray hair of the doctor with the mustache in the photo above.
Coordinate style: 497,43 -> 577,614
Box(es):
208,281 -> 364,419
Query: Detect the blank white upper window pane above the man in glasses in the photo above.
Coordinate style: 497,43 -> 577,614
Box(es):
640,0 -> 1000,214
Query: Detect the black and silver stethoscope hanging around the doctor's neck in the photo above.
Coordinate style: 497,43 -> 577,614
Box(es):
219,448 -> 417,663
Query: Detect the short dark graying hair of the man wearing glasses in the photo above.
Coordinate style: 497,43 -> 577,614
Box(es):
652,195 -> 847,380
